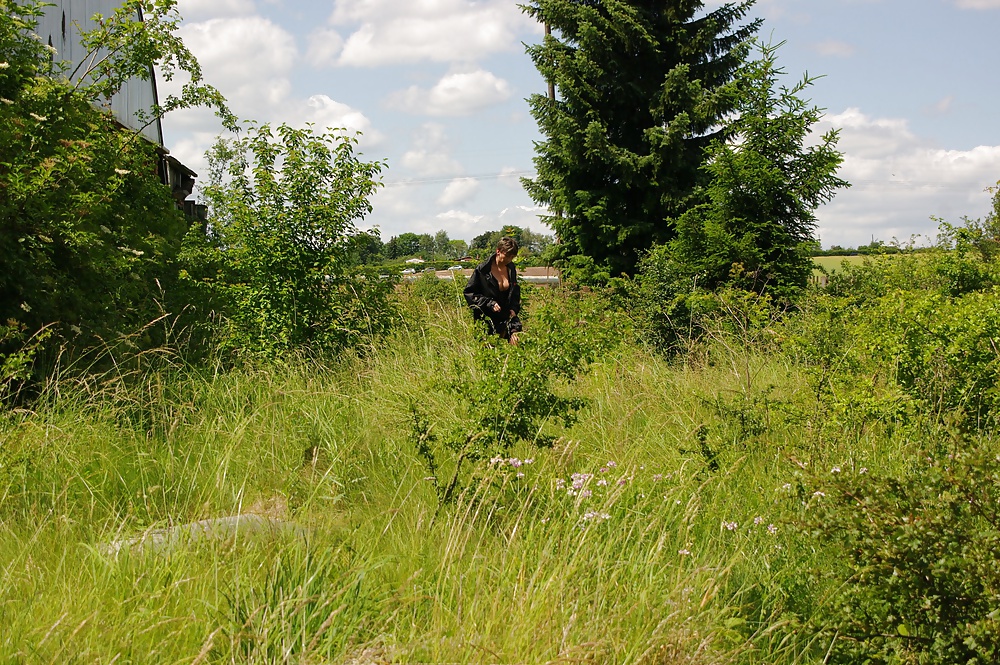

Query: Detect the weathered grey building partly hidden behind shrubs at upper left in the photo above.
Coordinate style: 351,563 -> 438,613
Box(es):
26,0 -> 205,218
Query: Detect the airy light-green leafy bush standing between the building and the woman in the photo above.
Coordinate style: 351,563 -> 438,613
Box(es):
186,124 -> 395,356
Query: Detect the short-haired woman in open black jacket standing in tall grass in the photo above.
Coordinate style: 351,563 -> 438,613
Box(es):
465,238 -> 521,344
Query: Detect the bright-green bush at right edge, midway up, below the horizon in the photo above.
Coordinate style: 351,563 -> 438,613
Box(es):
783,213 -> 1000,431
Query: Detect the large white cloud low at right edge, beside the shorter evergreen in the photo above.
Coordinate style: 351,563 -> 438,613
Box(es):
817,108 -> 1000,246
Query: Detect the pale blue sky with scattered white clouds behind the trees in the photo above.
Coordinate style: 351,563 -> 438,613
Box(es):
160,0 -> 1000,246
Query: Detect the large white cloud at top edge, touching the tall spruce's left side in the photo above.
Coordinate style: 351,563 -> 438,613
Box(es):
318,0 -> 541,67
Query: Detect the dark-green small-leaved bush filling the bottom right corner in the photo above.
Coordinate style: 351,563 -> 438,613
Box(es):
803,438 -> 1000,664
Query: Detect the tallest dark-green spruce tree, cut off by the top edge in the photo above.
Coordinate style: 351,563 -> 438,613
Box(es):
523,0 -> 760,275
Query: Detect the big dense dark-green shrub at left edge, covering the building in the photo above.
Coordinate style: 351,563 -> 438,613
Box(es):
0,0 -> 232,372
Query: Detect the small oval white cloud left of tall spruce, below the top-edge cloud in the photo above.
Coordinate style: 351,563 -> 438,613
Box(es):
388,69 -> 511,116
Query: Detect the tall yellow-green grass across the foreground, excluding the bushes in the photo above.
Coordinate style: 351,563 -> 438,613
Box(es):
0,298 -> 916,663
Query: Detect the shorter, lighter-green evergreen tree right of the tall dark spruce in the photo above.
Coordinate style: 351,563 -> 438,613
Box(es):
668,44 -> 850,300
